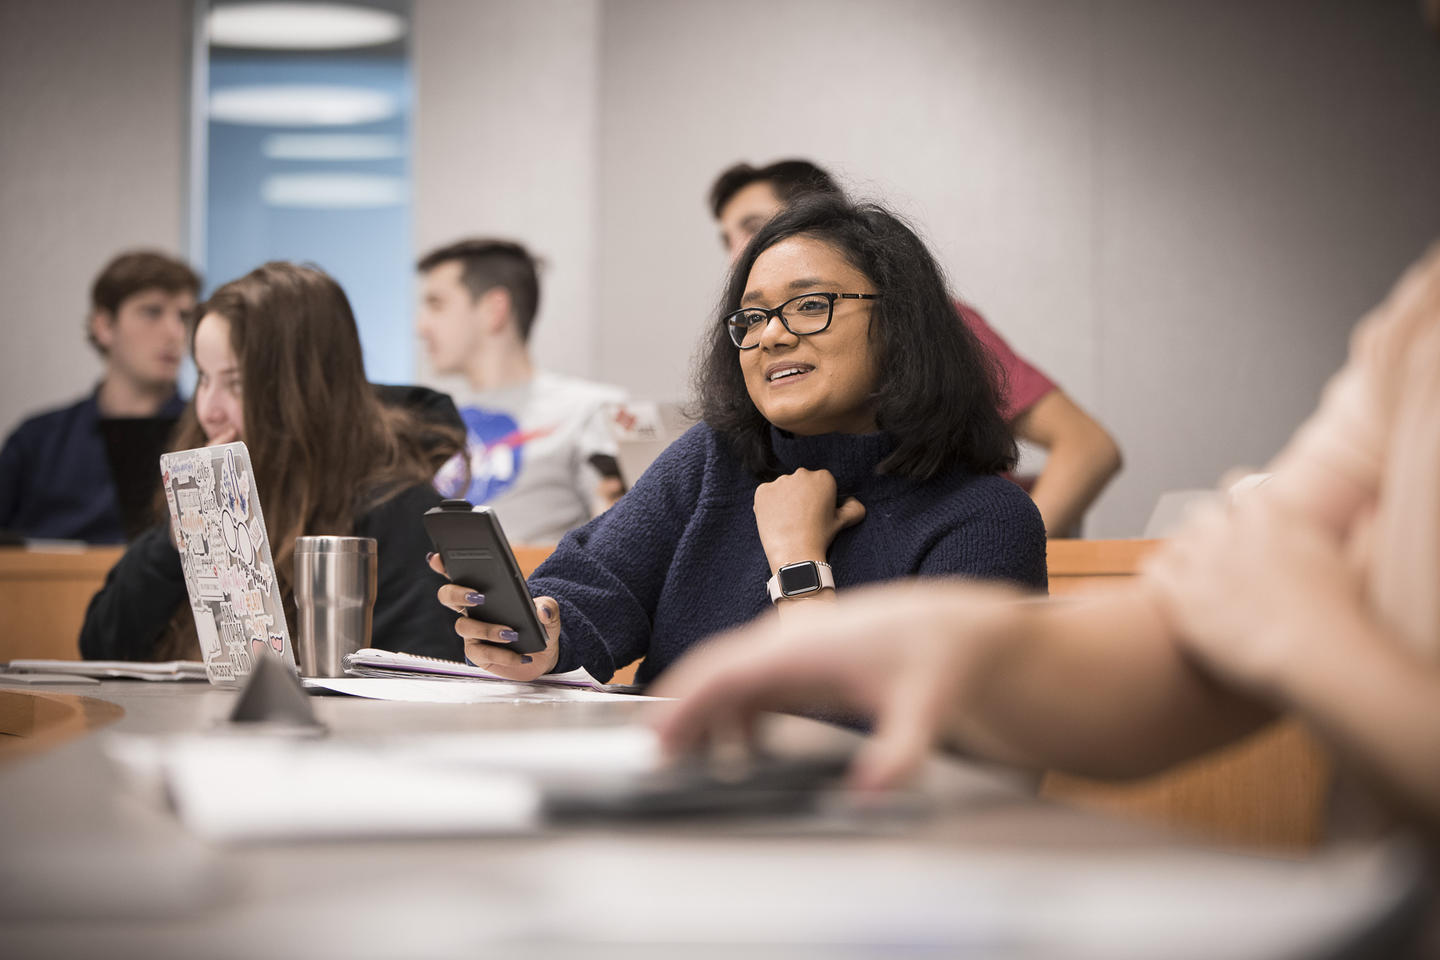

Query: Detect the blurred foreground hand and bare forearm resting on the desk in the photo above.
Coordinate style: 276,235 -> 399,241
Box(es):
655,580 -> 1273,786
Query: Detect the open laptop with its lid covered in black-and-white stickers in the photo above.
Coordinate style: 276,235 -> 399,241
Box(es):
160,442 -> 295,687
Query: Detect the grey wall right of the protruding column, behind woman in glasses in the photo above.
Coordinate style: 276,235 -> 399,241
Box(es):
596,0 -> 1440,537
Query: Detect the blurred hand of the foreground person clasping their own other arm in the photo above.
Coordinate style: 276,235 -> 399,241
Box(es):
1146,495 -> 1368,698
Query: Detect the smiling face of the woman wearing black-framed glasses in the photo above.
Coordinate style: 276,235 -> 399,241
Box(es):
736,236 -> 878,436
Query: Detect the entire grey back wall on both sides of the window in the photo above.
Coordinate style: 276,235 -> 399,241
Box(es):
0,0 -> 1440,535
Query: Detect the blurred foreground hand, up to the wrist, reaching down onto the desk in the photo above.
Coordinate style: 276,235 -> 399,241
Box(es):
652,580 -> 1021,789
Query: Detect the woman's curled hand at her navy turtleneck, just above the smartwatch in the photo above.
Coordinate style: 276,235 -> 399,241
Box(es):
755,469 -> 865,573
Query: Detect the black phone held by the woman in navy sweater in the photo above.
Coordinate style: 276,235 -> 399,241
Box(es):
423,499 -> 546,653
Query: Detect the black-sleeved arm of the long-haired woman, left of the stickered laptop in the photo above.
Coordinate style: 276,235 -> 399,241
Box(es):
81,524 -> 186,661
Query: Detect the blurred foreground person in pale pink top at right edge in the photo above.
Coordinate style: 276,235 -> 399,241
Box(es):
658,245 -> 1440,840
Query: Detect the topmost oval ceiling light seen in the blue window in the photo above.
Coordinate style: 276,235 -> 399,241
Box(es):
206,3 -> 405,50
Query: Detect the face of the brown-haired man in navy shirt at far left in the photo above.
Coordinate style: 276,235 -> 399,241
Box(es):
91,289 -> 194,390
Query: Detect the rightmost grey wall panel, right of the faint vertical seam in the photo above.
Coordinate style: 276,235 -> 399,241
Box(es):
1092,0 -> 1440,533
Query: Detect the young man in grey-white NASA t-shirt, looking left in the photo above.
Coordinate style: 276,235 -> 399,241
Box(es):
418,239 -> 625,544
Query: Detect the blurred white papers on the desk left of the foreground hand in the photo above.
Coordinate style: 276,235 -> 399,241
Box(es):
105,725 -> 661,842
